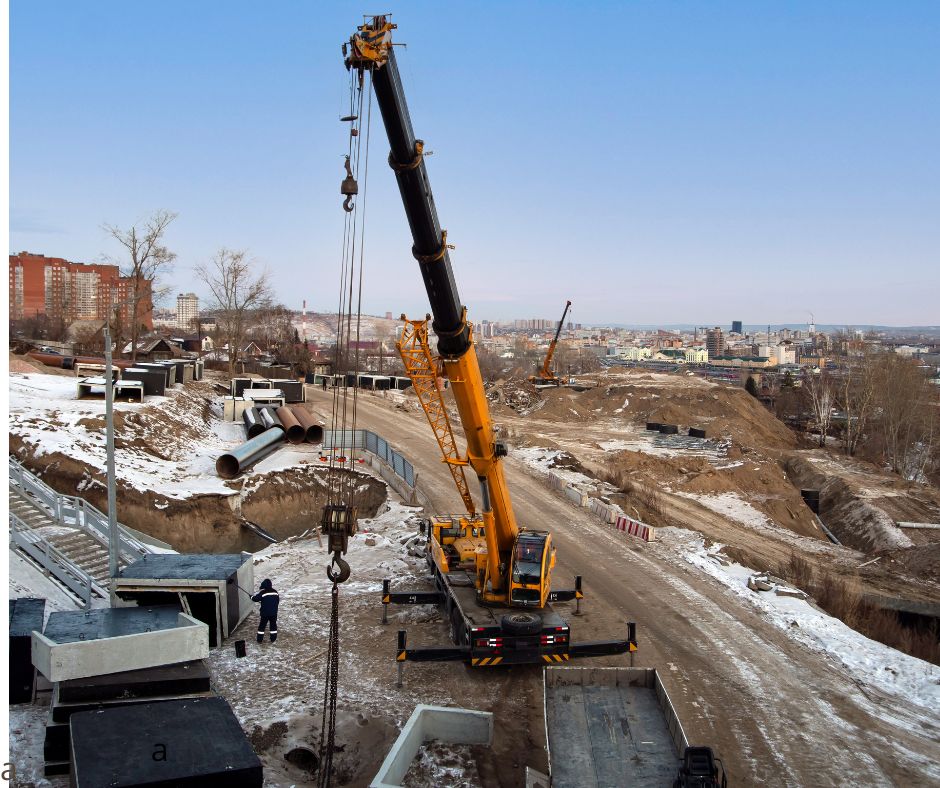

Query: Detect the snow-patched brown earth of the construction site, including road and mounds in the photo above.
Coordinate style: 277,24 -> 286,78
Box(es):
11,360 -> 940,786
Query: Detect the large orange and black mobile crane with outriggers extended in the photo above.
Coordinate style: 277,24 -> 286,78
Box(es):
343,16 -> 636,668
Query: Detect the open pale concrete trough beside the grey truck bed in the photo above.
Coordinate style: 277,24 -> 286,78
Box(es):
370,703 -> 493,788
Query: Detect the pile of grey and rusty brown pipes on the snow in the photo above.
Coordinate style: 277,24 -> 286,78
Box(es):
215,405 -> 323,479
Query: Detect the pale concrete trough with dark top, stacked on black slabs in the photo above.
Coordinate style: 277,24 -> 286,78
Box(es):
32,607 -> 209,682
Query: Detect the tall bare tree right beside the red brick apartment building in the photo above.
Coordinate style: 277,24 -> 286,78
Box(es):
104,206 -> 178,361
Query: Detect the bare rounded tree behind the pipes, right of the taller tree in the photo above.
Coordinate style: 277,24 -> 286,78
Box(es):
196,247 -> 272,375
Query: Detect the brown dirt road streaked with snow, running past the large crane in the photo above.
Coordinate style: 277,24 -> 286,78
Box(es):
311,392 -> 940,786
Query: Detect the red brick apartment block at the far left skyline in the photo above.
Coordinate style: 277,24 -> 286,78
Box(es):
10,252 -> 153,330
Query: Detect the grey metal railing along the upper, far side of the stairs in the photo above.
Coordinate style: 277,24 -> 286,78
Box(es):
9,457 -> 169,564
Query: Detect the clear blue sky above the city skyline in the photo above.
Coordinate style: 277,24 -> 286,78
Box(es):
10,0 -> 940,325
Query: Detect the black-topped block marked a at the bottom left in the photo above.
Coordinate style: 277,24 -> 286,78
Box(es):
71,698 -> 263,788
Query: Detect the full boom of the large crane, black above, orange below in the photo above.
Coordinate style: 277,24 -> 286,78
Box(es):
346,17 -> 519,596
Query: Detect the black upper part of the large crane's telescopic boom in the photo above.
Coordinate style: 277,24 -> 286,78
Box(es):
372,48 -> 470,358
